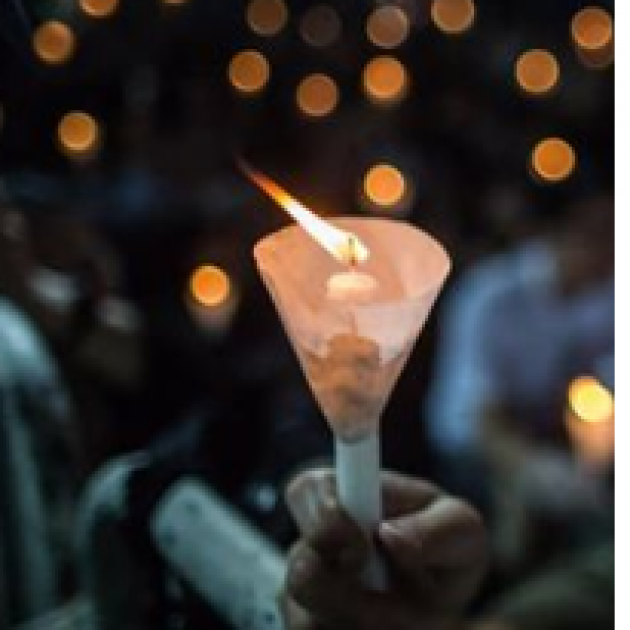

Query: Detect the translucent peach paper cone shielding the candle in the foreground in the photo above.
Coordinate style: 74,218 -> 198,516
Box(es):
254,217 -> 450,440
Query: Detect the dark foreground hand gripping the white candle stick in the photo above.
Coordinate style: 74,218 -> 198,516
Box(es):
285,470 -> 486,630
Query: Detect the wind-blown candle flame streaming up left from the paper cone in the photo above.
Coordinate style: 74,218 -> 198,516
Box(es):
241,162 -> 370,265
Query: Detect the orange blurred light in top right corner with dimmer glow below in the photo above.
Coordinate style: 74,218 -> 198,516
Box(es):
571,6 -> 614,68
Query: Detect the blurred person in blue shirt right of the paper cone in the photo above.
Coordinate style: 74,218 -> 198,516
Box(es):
426,196 -> 614,474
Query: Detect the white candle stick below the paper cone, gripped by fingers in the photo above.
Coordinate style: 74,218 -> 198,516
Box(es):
335,432 -> 387,591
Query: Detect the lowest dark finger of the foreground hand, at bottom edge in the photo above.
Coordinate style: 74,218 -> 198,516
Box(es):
286,542 -> 422,630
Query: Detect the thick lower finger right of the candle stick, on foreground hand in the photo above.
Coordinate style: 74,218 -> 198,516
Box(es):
378,497 -> 487,606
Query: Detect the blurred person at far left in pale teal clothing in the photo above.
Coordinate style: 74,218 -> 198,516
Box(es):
0,199 -> 144,627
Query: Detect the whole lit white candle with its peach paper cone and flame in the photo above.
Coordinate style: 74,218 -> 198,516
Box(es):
249,165 -> 450,588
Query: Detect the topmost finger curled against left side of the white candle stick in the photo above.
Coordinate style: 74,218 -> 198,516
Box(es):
286,469 -> 370,573
